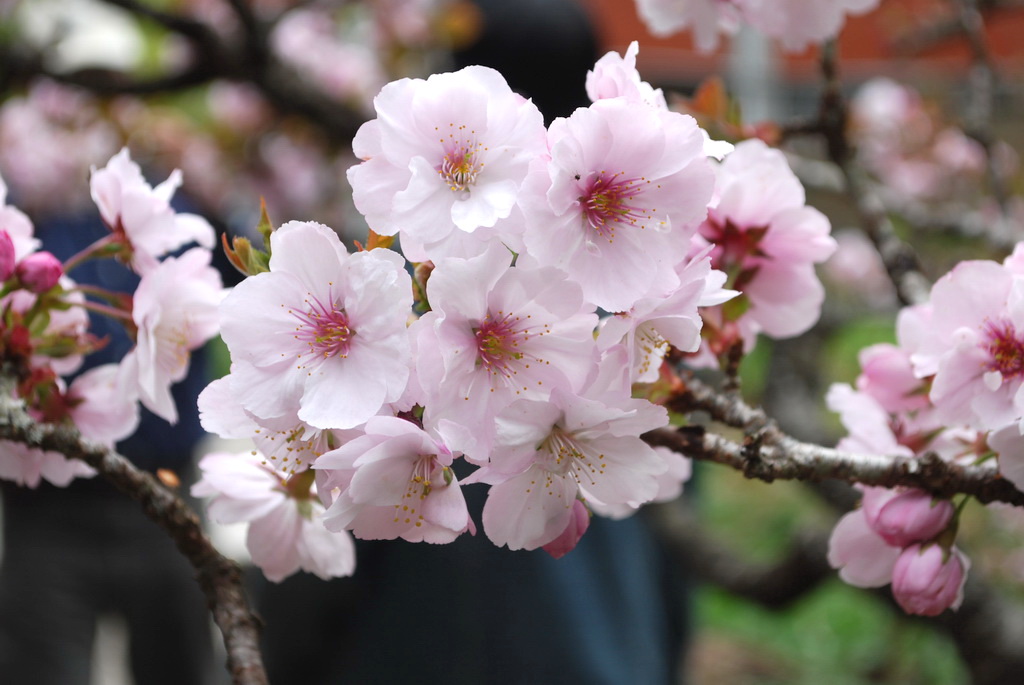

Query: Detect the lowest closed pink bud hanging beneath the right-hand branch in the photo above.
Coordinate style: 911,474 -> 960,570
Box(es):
893,545 -> 969,616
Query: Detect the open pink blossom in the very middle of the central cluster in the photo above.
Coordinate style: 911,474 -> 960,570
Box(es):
412,246 -> 597,462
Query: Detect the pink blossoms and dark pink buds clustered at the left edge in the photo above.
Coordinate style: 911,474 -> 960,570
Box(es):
0,149 -> 223,486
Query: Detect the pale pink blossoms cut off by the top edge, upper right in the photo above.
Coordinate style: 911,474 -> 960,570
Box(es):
637,0 -> 879,52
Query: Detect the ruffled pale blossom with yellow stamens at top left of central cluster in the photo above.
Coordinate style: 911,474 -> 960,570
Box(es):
348,67 -> 546,261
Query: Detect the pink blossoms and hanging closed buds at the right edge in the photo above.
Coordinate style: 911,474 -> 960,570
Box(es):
828,246 -> 1024,615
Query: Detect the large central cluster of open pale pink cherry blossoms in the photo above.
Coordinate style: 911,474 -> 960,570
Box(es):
194,44 -> 834,580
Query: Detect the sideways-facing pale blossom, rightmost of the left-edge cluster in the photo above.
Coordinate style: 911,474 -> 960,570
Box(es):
121,242 -> 224,423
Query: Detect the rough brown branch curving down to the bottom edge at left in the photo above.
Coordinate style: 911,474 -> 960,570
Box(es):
0,365 -> 267,685
